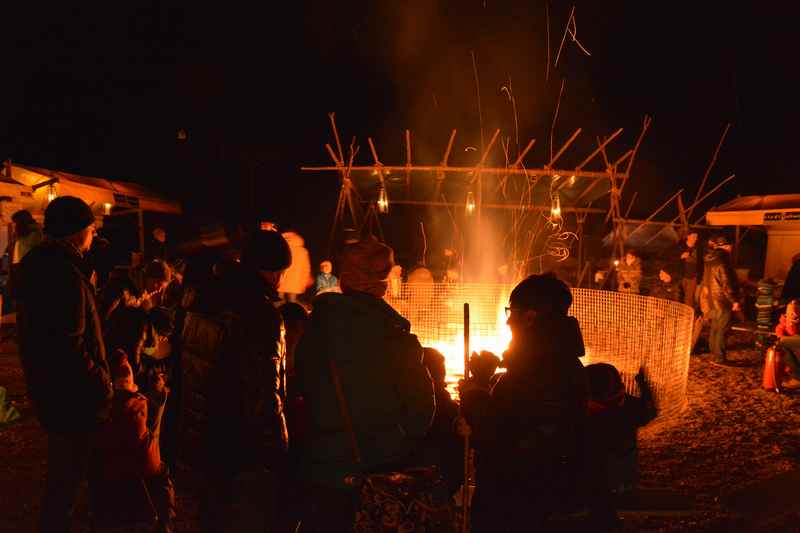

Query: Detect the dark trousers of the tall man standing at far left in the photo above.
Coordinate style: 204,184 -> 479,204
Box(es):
39,433 -> 89,533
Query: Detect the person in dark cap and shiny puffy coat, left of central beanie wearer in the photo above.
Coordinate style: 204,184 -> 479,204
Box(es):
181,230 -> 291,532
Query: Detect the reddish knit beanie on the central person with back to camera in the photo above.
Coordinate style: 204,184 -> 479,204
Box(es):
339,238 -> 394,298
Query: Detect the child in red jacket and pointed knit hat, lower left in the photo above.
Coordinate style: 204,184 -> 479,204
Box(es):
90,350 -> 175,531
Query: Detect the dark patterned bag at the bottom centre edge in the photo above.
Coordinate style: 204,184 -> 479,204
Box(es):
347,466 -> 458,533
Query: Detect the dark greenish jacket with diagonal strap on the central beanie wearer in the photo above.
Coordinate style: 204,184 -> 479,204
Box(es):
295,292 -> 435,487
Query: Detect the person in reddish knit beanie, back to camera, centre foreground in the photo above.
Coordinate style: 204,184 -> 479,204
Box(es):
295,238 -> 435,532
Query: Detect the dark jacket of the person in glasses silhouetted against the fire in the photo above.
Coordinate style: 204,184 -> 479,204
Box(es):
464,316 -> 588,476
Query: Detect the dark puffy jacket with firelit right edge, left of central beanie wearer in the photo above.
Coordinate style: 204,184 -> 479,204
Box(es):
180,267 -> 288,472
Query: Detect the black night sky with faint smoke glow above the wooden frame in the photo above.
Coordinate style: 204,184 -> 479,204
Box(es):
0,0 -> 800,264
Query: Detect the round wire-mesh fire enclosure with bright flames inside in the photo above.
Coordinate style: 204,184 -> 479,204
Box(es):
386,283 -> 693,420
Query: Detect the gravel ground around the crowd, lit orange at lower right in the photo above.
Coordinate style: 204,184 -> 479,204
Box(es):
0,335 -> 800,532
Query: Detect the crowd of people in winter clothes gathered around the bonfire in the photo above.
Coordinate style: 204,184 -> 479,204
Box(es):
7,196 -> 798,532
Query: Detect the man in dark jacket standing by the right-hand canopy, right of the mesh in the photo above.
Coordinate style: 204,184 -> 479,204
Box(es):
700,235 -> 739,363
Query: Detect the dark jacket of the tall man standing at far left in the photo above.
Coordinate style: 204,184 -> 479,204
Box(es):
18,240 -> 112,433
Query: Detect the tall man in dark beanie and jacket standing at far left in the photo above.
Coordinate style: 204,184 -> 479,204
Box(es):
18,196 -> 112,531
